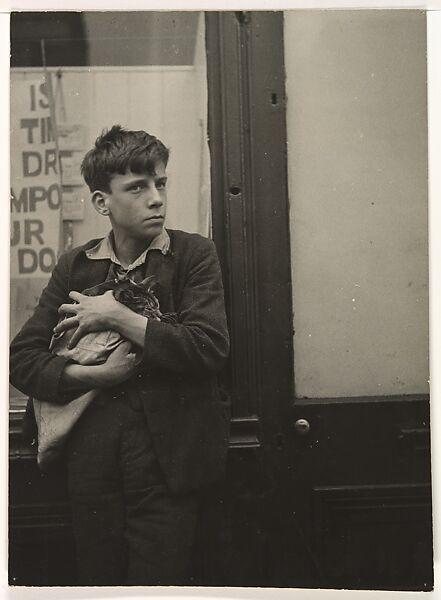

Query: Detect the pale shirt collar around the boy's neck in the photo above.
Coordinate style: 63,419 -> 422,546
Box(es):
86,229 -> 170,280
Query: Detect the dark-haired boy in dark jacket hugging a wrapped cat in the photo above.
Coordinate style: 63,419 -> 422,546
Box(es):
10,125 -> 229,585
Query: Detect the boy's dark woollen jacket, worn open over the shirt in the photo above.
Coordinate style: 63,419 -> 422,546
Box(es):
10,230 -> 229,492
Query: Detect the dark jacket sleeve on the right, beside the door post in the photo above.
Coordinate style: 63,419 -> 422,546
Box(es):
141,238 -> 229,377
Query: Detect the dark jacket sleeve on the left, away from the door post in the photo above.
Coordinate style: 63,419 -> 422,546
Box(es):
10,255 -> 69,403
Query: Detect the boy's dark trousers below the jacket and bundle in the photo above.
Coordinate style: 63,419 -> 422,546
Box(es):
66,398 -> 199,585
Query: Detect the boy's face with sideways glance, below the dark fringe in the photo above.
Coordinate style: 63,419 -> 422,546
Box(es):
105,162 -> 167,242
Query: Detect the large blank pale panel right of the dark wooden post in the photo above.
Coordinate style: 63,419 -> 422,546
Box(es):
285,11 -> 428,397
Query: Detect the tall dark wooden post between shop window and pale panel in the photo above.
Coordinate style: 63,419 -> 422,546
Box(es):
206,12 -> 294,460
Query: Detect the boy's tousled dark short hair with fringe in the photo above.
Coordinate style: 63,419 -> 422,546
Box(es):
81,125 -> 169,192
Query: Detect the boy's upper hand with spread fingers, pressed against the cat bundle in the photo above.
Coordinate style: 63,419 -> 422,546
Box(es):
54,291 -> 127,348
